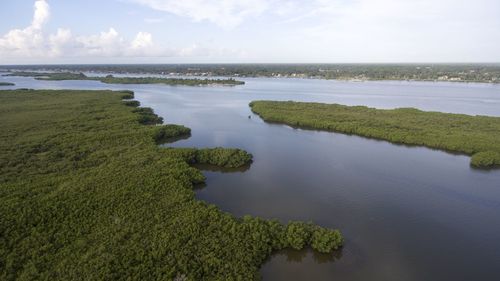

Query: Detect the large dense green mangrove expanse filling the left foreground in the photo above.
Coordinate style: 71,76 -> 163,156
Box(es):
0,90 -> 343,281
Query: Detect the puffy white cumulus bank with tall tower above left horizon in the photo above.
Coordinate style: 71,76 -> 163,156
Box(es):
0,0 -> 171,60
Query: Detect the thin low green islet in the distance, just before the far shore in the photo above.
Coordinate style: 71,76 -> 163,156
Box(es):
7,72 -> 245,86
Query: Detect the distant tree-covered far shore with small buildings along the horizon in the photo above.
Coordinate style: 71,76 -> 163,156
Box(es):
4,63 -> 500,83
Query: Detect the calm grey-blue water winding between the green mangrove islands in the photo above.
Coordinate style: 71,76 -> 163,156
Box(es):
0,74 -> 500,280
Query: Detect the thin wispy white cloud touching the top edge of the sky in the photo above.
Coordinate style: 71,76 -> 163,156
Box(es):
131,0 -> 271,28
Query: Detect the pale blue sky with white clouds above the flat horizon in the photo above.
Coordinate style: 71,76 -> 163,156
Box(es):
0,0 -> 500,64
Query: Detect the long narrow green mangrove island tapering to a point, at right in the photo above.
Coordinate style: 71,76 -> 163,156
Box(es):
250,101 -> 500,167
